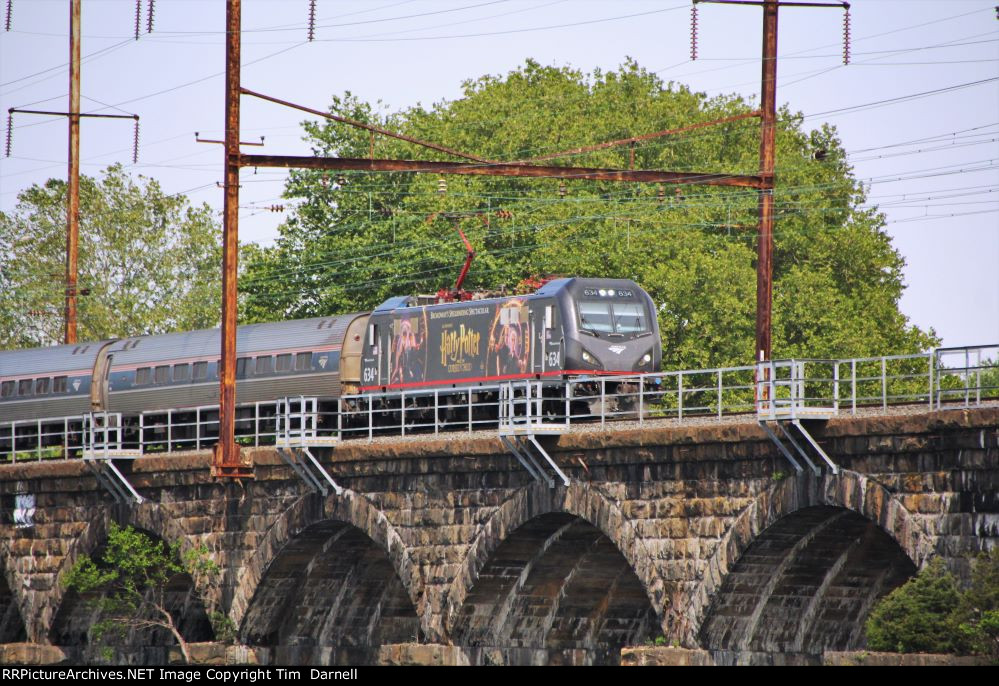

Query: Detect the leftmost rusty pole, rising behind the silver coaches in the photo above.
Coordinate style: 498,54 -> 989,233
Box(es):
64,0 -> 80,343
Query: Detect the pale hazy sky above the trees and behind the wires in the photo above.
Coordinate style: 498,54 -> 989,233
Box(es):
0,0 -> 999,346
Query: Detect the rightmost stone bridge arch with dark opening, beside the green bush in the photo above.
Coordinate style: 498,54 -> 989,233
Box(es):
684,470 -> 933,652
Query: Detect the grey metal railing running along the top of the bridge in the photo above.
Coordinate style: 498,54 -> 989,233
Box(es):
0,344 -> 999,462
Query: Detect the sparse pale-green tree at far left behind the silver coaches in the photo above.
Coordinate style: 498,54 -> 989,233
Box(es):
0,165 -> 221,348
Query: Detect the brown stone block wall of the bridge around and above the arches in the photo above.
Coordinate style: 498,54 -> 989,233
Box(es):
0,408 -> 999,664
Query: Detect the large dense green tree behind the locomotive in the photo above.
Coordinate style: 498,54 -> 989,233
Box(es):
241,61 -> 935,368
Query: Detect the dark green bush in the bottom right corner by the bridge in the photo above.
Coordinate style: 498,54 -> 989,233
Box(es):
866,550 -> 999,660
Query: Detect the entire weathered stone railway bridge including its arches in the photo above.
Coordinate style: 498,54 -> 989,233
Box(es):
0,408 -> 999,664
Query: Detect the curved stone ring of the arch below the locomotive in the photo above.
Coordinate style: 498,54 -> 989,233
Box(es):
443,481 -> 674,639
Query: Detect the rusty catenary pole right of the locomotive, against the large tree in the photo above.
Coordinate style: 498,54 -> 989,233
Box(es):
756,0 -> 777,360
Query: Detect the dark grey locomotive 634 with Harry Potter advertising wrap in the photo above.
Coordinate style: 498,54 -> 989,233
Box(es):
359,278 -> 662,392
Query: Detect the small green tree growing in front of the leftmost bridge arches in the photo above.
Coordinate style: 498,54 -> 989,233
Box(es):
64,523 -> 227,663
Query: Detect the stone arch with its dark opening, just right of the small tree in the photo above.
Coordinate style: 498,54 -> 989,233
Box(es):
230,490 -> 422,663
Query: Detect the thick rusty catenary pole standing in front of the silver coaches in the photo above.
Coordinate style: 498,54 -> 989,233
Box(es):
213,0 -> 249,476
